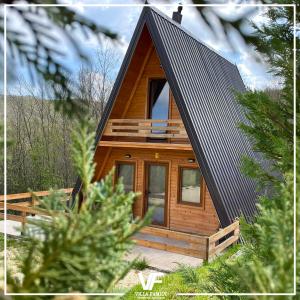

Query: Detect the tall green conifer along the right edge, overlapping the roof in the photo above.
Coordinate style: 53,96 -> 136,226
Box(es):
203,7 -> 299,299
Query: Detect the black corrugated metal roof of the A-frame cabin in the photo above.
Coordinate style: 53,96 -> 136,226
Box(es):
74,7 -> 257,226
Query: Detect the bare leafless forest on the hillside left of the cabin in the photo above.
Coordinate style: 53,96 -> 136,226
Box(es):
0,44 -> 120,194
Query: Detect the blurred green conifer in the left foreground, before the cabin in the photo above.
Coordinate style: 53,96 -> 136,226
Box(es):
9,120 -> 147,293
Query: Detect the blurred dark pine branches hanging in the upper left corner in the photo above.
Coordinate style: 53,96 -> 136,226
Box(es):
0,0 -> 118,117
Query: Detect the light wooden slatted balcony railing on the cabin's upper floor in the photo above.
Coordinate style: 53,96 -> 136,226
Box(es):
104,119 -> 188,139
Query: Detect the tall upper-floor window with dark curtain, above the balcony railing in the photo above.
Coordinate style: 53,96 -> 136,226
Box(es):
149,79 -> 169,120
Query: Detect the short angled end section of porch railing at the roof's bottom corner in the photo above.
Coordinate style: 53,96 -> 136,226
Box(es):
207,221 -> 240,259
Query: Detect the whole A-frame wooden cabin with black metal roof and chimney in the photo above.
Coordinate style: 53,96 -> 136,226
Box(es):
75,7 -> 256,258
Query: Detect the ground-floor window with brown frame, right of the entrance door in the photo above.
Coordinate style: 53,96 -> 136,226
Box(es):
179,167 -> 203,206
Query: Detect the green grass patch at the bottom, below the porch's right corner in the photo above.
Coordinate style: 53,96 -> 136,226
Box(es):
124,245 -> 240,300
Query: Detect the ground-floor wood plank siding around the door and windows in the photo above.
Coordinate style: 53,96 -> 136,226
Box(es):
98,148 -> 220,235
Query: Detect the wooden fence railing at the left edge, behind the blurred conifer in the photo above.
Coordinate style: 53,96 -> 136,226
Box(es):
0,188 -> 73,224
